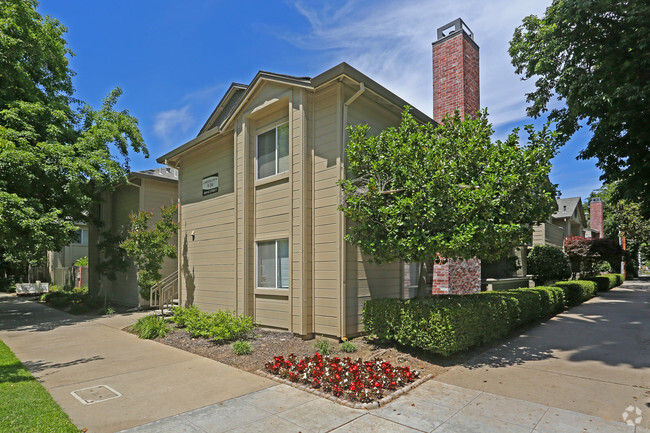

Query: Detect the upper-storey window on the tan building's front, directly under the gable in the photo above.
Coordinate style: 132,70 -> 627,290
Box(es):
257,123 -> 289,179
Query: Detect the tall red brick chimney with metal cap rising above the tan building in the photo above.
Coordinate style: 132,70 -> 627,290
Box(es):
433,18 -> 481,123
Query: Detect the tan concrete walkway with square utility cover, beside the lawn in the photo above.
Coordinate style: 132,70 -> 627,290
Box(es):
0,294 -> 275,433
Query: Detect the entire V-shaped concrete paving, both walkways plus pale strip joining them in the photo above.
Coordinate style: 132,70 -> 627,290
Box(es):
0,282 -> 650,433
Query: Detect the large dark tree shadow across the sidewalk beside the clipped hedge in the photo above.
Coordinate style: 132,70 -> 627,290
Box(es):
456,281 -> 650,369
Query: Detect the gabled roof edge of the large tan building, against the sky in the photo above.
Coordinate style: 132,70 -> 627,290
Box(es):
156,62 -> 433,164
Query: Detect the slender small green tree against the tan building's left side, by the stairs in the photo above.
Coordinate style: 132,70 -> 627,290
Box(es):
121,206 -> 178,299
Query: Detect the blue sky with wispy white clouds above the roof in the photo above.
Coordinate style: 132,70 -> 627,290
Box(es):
38,0 -> 601,198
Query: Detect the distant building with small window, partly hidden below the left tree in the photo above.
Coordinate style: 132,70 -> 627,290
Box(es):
47,223 -> 88,287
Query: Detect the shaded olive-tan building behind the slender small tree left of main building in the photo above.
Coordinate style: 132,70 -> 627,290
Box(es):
88,168 -> 178,306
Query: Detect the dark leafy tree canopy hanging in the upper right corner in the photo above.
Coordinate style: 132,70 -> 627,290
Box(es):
510,0 -> 650,216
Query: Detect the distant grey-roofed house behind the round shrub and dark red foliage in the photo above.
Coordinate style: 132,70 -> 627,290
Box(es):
533,197 -> 602,248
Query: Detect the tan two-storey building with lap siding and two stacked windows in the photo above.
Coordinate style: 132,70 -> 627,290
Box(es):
158,20 -> 480,337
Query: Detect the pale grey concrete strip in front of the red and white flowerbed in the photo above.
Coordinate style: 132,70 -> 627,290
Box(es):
123,380 -> 650,433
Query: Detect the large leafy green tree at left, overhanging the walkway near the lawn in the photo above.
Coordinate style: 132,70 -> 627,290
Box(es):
0,0 -> 148,272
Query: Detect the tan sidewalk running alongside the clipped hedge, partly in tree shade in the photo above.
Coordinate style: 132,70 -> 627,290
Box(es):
436,280 -> 650,428
